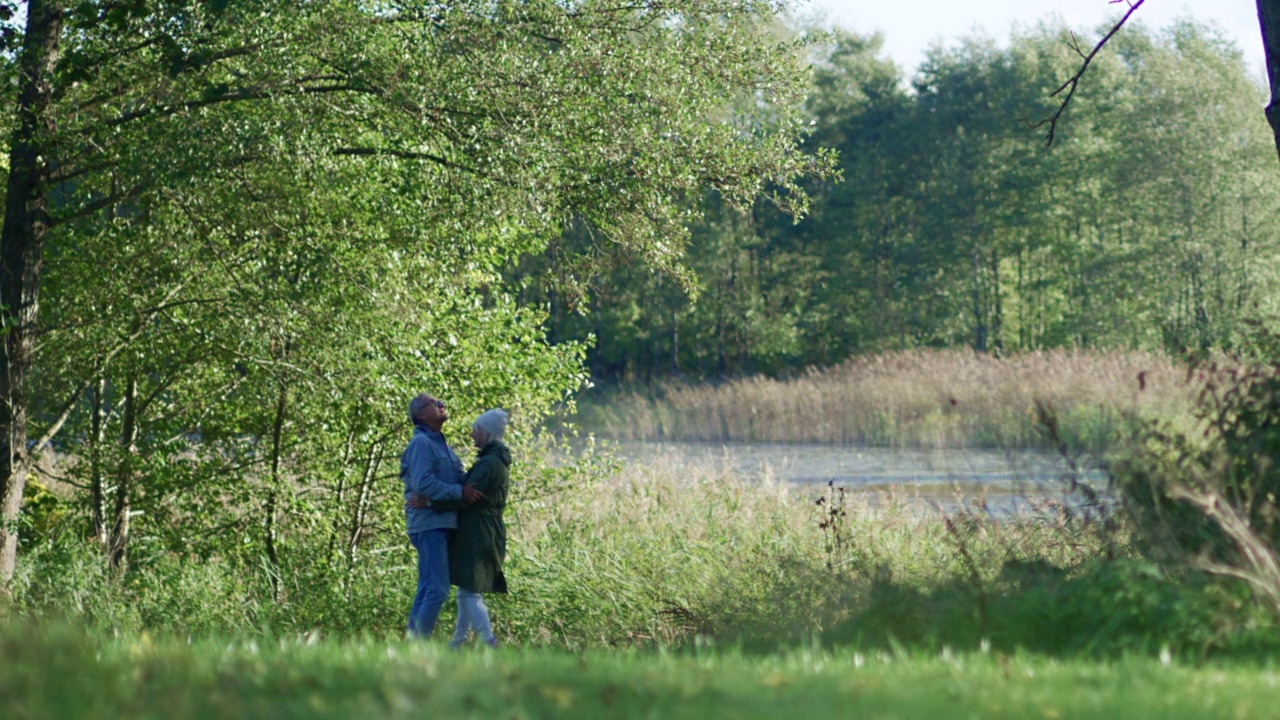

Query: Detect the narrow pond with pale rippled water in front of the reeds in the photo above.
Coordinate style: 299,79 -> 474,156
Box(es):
617,442 -> 1107,512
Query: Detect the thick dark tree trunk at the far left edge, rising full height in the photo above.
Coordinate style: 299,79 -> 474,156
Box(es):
0,0 -> 63,592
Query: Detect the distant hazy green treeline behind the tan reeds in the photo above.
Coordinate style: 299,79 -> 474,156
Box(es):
517,23 -> 1280,379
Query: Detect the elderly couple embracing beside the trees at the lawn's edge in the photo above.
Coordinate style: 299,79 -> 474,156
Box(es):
401,393 -> 511,647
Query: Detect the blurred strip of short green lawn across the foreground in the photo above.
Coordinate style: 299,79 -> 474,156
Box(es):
0,626 -> 1280,720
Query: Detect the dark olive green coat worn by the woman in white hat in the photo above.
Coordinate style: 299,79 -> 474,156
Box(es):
449,441 -> 511,593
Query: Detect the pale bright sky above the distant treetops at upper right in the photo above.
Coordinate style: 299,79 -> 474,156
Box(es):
799,0 -> 1265,77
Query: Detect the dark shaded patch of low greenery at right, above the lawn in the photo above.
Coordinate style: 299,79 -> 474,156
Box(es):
822,560 -> 1280,660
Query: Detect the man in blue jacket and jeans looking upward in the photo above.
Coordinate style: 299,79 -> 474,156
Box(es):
401,393 -> 480,638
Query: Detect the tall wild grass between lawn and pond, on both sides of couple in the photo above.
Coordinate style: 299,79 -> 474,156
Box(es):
17,448 -> 1275,657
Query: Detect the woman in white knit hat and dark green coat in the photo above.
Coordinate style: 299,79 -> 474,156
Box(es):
449,410 -> 511,647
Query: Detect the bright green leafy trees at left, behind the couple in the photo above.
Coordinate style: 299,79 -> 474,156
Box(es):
0,0 -> 829,584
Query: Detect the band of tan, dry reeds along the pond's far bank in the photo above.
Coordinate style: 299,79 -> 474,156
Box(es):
577,350 -> 1194,450
